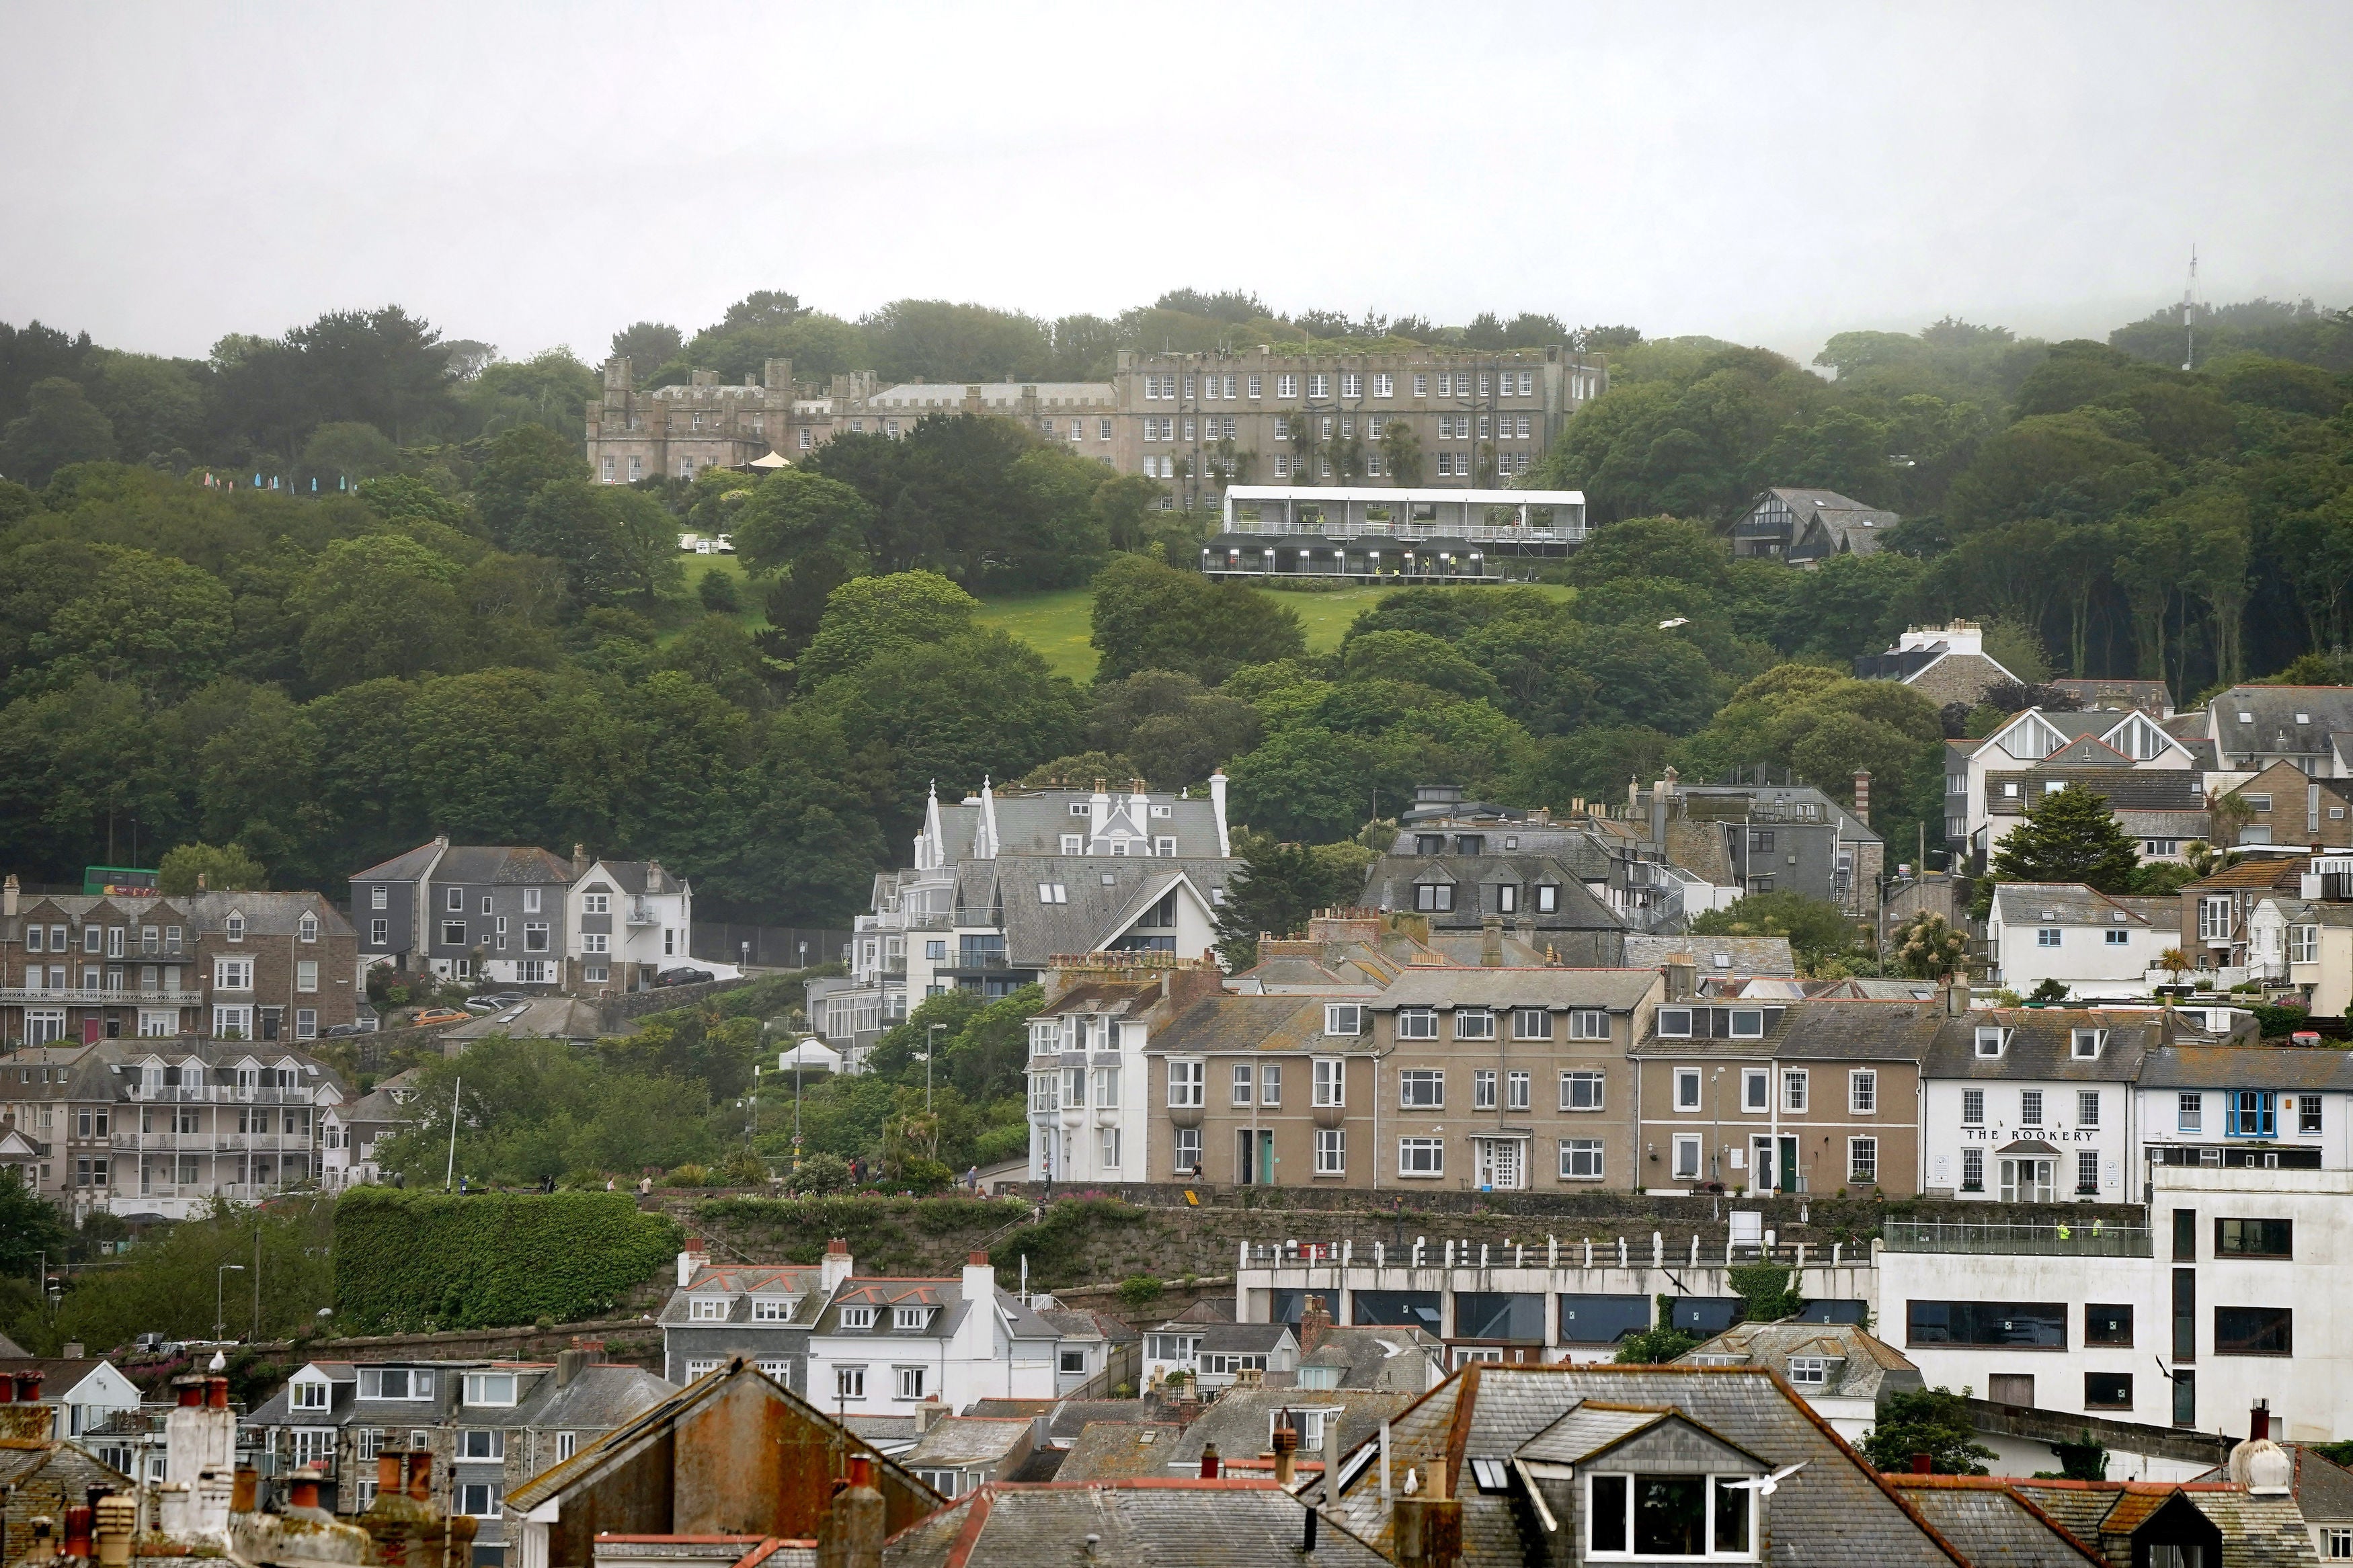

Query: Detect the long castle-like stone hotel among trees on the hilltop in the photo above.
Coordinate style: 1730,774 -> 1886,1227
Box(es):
588,345 -> 1609,508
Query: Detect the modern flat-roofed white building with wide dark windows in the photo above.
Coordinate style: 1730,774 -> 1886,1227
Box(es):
1878,1161 -> 2353,1448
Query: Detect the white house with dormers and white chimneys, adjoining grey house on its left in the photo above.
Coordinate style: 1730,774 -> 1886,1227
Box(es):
809,1251 -> 1062,1415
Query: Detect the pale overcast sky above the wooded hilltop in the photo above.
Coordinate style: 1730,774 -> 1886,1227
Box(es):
0,0 -> 2353,360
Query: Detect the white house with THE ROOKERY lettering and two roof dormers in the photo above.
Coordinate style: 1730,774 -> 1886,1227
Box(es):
1920,1009 -> 2165,1203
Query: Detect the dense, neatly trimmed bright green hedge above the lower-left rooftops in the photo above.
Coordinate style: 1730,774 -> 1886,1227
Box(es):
334,1187 -> 680,1333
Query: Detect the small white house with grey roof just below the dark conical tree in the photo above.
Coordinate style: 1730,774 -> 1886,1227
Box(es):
1986,882 -> 2182,1001
